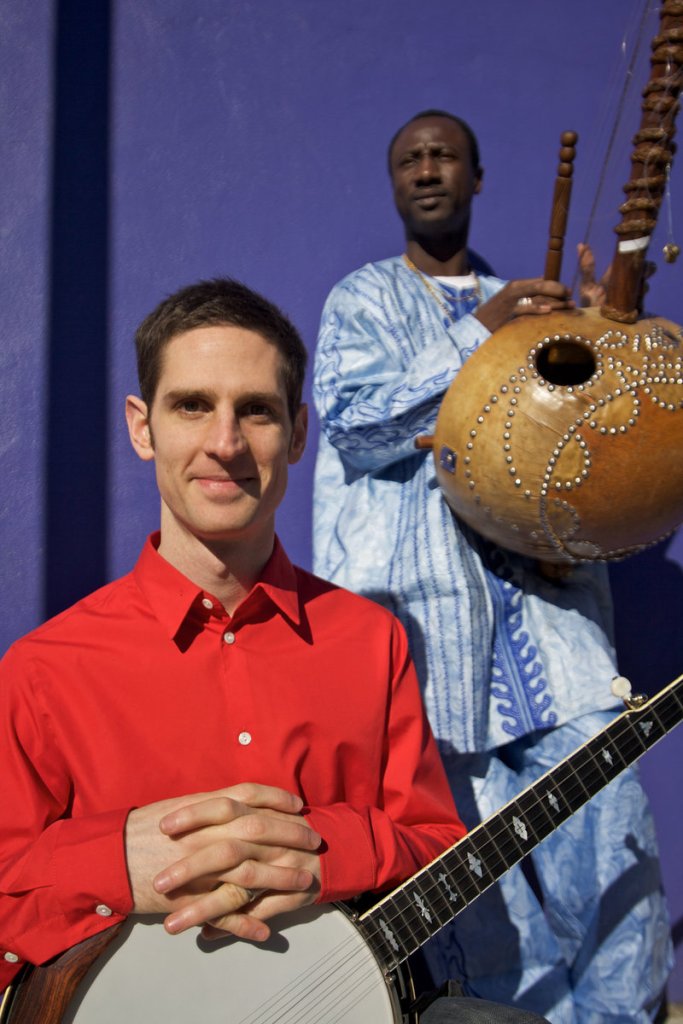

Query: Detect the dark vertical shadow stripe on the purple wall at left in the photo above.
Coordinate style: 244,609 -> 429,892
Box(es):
43,0 -> 110,617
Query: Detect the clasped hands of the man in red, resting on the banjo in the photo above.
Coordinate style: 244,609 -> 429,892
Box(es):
125,783 -> 321,941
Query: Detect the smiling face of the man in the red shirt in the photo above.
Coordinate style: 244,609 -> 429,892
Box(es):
128,326 -> 306,550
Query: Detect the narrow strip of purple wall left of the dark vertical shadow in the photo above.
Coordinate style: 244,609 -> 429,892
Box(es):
0,0 -> 52,634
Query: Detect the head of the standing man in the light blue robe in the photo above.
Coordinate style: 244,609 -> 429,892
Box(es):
390,117 -> 481,237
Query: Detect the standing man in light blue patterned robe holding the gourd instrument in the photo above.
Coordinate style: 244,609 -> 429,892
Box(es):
313,111 -> 671,1024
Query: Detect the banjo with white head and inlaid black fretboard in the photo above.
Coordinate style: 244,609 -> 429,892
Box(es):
5,676 -> 683,1024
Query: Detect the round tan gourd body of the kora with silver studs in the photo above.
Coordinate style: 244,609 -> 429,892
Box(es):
433,308 -> 683,563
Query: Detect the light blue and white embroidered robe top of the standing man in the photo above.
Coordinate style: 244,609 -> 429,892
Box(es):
313,257 -> 616,753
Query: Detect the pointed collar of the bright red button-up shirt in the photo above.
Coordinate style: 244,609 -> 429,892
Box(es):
133,531 -> 301,639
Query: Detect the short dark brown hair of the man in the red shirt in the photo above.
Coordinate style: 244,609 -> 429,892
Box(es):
135,278 -> 307,423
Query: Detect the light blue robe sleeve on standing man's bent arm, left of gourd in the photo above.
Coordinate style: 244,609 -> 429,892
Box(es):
313,268 -> 493,473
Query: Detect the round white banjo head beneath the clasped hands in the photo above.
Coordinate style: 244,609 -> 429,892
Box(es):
62,904 -> 401,1024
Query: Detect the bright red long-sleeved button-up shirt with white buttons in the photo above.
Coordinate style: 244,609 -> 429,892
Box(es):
0,537 -> 464,990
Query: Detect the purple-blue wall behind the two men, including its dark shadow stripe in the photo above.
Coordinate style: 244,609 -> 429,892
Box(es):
0,0 -> 683,999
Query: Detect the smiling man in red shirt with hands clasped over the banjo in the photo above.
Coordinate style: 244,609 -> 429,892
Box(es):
0,280 -> 485,1019
